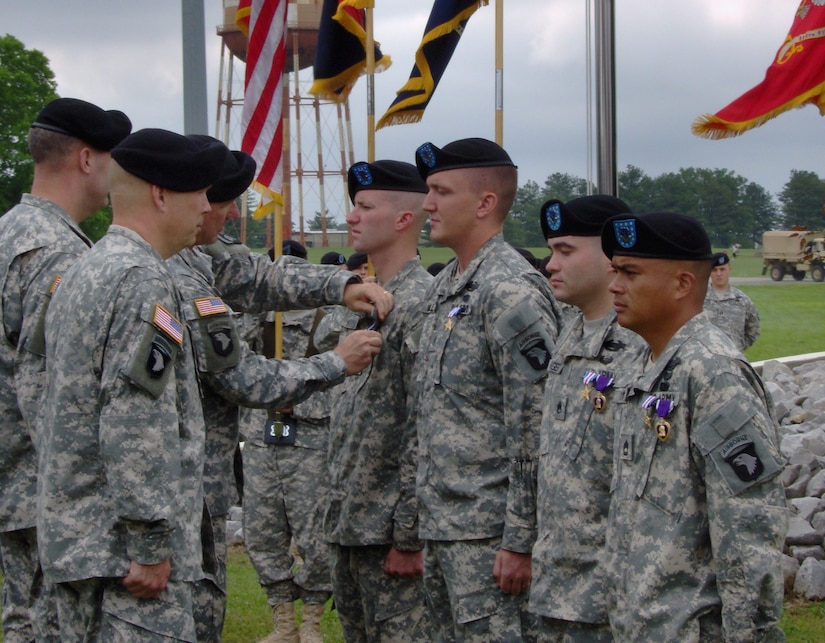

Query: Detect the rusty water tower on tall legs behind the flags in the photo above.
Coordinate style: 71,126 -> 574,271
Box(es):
215,0 -> 354,246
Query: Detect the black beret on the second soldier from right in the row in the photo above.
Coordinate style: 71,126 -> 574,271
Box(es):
540,194 -> 630,239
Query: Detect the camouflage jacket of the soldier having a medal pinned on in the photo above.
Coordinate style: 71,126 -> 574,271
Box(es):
319,258 -> 432,551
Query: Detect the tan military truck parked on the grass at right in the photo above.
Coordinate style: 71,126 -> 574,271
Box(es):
762,230 -> 825,281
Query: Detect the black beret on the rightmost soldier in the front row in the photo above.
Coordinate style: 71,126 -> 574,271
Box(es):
602,212 -> 713,261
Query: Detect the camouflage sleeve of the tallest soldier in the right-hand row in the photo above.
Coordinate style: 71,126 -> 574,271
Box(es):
491,284 -> 558,553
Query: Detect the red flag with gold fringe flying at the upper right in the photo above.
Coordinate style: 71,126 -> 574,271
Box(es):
691,0 -> 825,138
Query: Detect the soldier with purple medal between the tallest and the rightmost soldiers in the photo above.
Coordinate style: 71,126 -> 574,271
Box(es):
530,195 -> 643,643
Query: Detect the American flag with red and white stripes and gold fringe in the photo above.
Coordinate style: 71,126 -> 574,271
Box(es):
235,0 -> 287,219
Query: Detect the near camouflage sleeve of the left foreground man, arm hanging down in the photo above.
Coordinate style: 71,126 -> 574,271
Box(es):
99,279 -> 186,564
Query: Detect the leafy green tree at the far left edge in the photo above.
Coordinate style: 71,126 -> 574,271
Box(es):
0,34 -> 57,214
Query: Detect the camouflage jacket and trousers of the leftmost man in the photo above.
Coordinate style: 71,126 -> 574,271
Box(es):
0,194 -> 92,642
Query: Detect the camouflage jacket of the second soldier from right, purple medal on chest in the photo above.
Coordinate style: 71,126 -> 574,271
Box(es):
530,311 -> 645,640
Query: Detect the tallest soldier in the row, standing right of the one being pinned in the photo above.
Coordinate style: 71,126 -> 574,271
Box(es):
416,139 -> 558,642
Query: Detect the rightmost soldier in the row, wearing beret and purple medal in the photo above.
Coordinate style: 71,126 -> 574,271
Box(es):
602,212 -> 788,643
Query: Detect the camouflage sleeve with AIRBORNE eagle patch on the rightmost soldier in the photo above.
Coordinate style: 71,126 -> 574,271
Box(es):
693,373 -> 788,642
